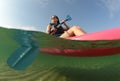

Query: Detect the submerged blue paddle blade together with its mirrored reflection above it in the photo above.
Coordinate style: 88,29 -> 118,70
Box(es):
7,30 -> 39,70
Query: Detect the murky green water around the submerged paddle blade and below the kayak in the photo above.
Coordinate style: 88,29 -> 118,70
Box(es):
0,28 -> 120,81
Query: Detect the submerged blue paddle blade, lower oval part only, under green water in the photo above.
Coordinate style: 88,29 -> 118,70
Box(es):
7,47 -> 38,70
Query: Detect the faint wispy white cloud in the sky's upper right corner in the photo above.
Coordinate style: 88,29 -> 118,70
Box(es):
101,0 -> 120,17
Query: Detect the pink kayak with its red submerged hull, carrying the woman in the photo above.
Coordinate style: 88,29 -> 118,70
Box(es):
40,28 -> 120,57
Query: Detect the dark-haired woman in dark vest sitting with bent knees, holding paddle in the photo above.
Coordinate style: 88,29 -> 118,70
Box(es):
46,15 -> 86,38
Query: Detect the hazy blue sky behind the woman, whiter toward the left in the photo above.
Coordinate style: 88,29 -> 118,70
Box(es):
0,0 -> 120,33
